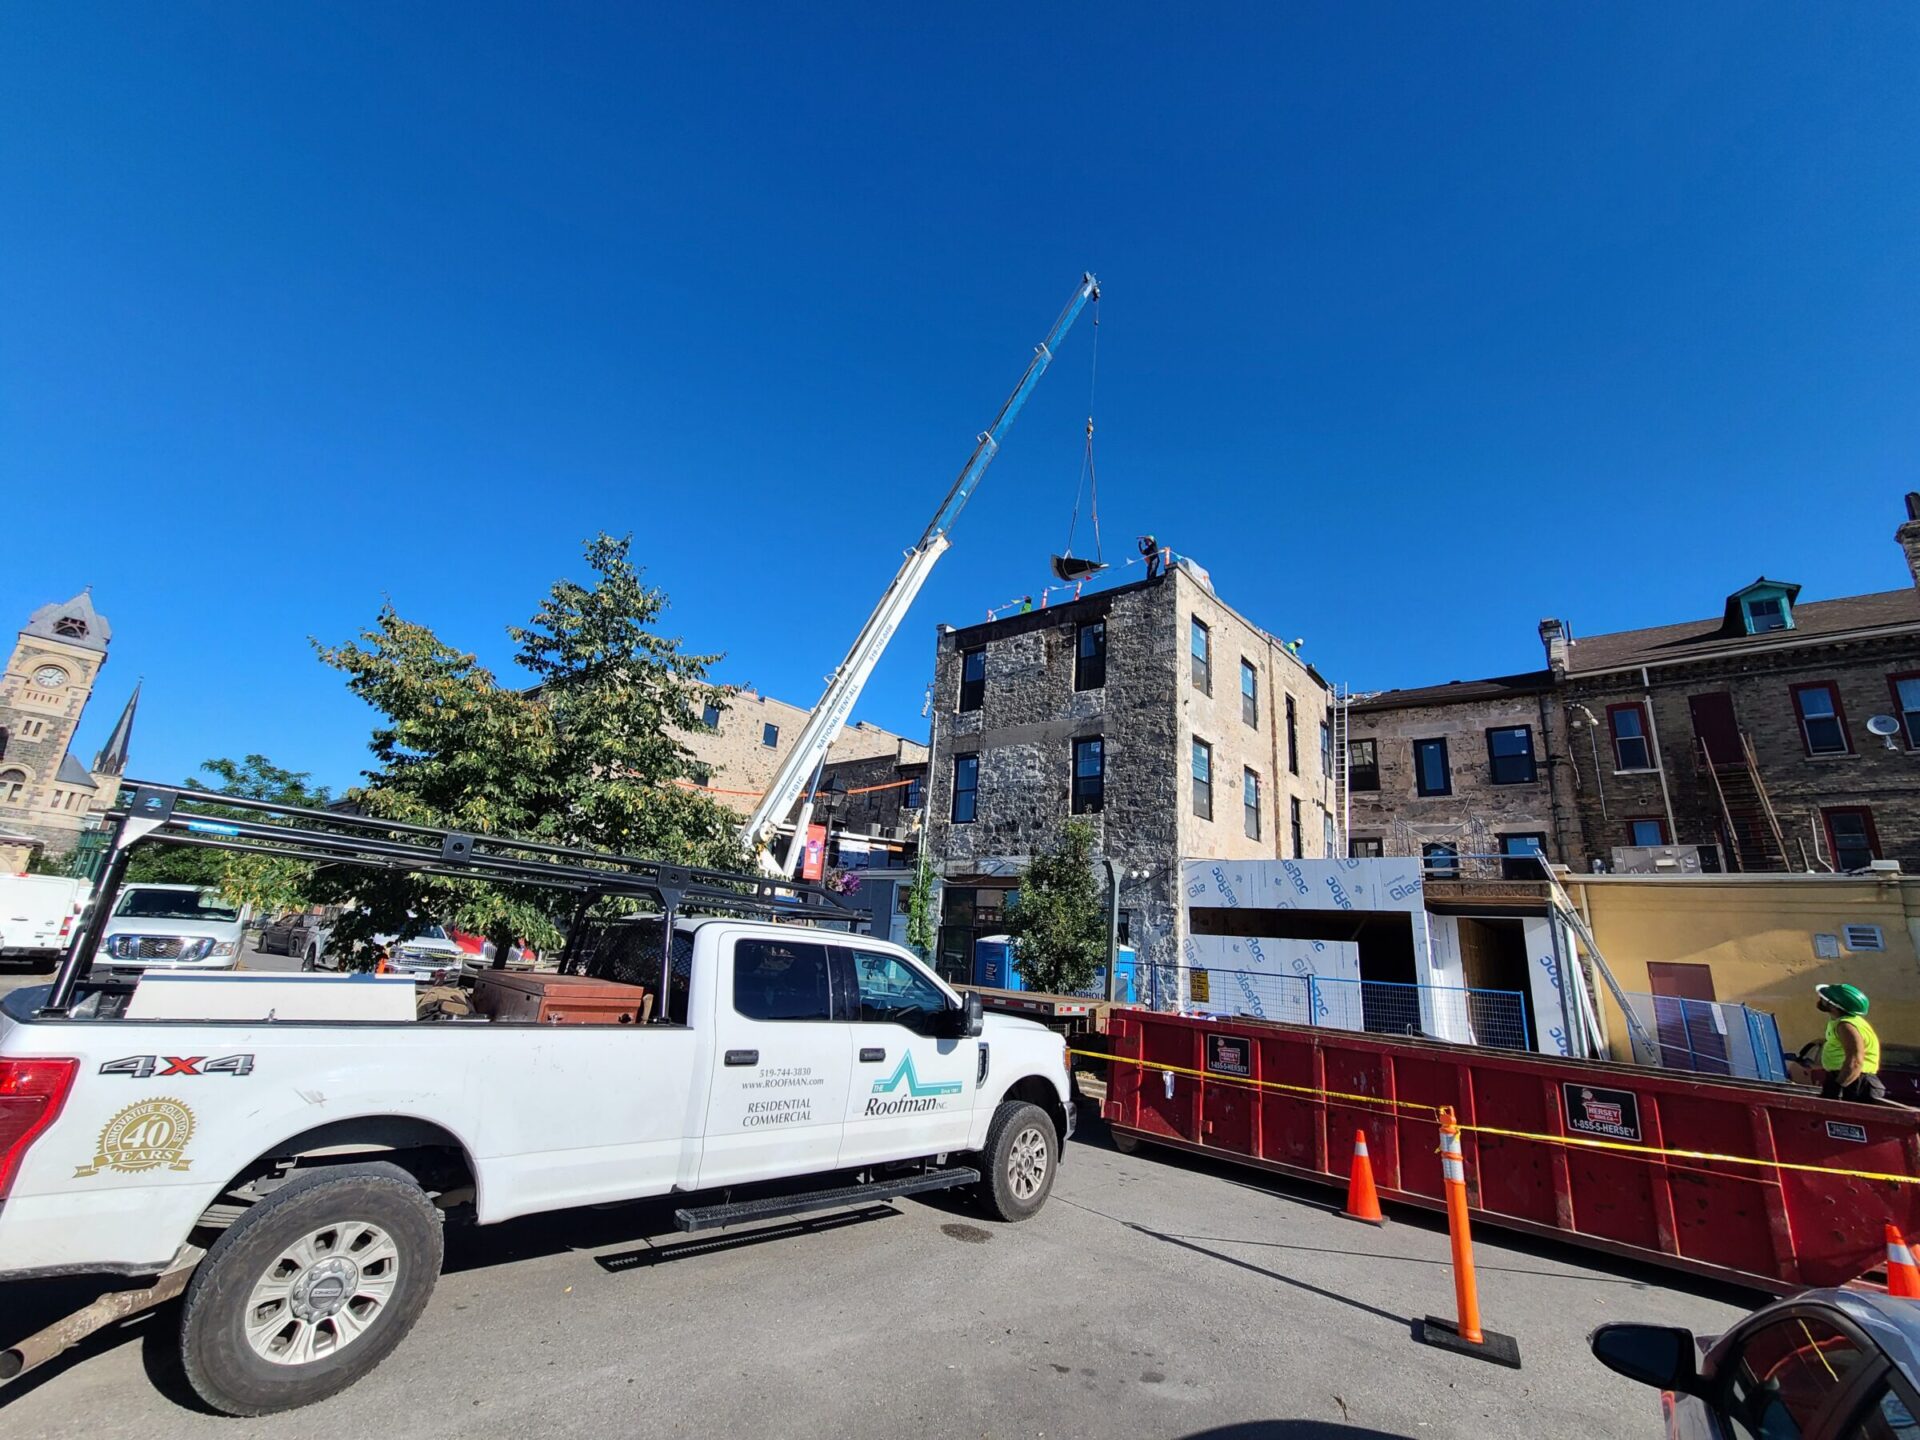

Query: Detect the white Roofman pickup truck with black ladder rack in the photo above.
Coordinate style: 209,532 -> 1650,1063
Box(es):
0,787 -> 1073,1415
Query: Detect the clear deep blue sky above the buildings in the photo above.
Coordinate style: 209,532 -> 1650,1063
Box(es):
0,0 -> 1920,785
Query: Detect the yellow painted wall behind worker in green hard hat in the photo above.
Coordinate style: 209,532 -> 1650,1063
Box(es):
1563,876 -> 1920,1064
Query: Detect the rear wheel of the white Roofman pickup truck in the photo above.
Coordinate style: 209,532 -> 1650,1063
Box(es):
180,1164 -> 442,1415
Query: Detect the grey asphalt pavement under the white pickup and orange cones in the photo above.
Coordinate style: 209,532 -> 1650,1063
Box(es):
0,1013 -> 1757,1440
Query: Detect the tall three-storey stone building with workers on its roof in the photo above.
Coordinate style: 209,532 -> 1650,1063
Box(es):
927,559 -> 1336,977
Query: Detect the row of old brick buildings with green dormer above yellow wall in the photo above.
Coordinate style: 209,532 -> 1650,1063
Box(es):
1348,495 -> 1920,874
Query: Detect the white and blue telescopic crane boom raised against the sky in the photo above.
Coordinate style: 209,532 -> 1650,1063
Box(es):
745,275 -> 1100,874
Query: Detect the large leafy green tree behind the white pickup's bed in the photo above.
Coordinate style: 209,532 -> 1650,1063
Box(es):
317,536 -> 747,971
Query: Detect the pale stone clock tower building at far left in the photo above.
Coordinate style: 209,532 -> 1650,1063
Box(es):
0,591 -> 140,870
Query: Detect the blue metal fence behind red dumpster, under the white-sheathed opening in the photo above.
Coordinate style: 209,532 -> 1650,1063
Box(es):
1135,964 -> 1534,1050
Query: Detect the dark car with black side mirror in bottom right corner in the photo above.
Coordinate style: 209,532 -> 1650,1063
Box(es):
1588,1290 -> 1920,1440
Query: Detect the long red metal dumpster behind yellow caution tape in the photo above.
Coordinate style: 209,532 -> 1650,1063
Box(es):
1104,1010 -> 1920,1292
